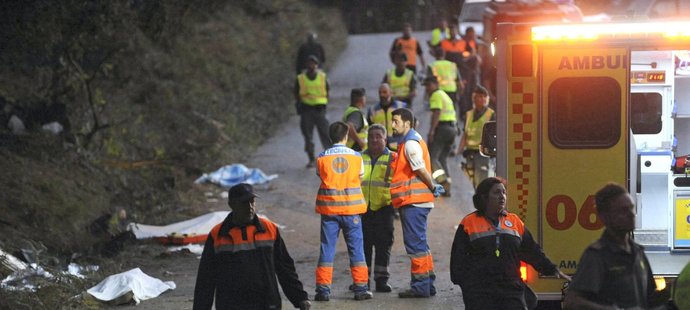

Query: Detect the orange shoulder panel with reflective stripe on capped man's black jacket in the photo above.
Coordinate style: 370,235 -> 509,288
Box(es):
211,217 -> 278,254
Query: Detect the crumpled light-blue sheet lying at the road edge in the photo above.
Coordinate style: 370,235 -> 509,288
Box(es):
194,164 -> 278,188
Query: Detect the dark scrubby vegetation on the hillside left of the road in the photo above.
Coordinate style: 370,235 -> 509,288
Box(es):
0,0 -> 347,309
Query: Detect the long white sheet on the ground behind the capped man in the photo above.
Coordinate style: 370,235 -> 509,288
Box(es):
128,211 -> 230,239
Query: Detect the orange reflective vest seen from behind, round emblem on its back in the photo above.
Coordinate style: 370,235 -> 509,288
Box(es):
316,144 -> 367,215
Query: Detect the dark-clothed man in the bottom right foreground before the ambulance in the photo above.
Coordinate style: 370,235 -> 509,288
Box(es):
563,183 -> 670,310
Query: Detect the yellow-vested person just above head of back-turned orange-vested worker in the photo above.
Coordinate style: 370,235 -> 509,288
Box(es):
343,88 -> 369,152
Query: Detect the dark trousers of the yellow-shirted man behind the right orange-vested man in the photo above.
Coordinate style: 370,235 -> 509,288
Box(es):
429,122 -> 458,183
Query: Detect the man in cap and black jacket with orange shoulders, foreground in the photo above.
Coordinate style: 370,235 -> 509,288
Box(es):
193,183 -> 311,310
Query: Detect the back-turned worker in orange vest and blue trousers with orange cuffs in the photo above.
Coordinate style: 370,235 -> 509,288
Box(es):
314,121 -> 373,301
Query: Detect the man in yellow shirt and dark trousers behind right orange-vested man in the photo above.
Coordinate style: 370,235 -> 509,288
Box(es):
424,75 -> 458,197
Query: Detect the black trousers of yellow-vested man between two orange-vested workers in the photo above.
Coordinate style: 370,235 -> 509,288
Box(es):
362,206 -> 395,282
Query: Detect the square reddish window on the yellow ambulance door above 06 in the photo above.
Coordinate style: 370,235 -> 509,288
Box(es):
548,77 -> 621,148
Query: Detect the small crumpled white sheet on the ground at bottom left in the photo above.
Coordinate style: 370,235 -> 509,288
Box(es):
87,268 -> 177,304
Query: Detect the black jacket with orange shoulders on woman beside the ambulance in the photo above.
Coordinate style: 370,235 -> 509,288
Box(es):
450,212 -> 556,292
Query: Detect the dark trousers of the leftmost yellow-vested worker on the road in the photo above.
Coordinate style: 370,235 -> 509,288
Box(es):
299,104 -> 331,160
